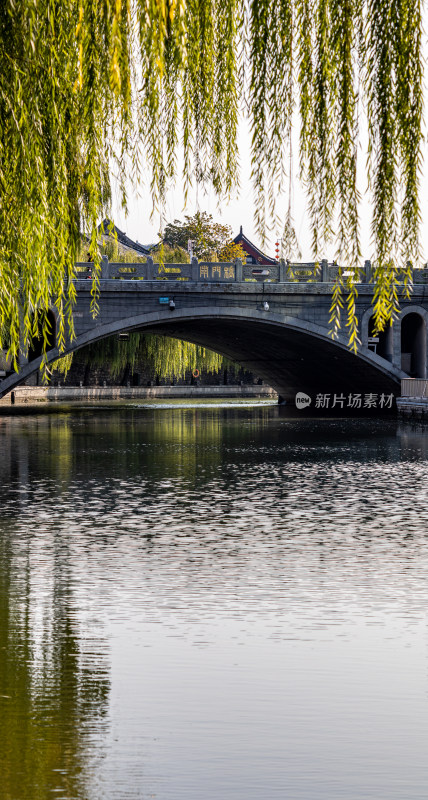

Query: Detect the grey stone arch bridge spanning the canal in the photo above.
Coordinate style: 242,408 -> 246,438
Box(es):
0,257 -> 428,401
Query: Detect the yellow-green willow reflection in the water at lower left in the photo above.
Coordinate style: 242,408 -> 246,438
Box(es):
0,520 -> 110,800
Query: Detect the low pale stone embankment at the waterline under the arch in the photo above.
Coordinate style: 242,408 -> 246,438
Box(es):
0,384 -> 278,409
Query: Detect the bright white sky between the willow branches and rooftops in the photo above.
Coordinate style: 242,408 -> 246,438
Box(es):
113,115 -> 428,261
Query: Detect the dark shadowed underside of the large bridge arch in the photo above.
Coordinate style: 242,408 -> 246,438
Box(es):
144,319 -> 399,400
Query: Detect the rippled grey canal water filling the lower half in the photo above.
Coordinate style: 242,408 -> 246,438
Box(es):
0,404 -> 428,800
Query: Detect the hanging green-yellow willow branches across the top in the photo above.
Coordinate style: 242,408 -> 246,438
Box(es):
0,0 -> 423,362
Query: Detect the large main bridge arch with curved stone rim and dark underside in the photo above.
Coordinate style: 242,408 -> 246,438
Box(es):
0,305 -> 404,400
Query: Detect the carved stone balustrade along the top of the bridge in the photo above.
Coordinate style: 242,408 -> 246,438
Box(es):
76,256 -> 428,284
